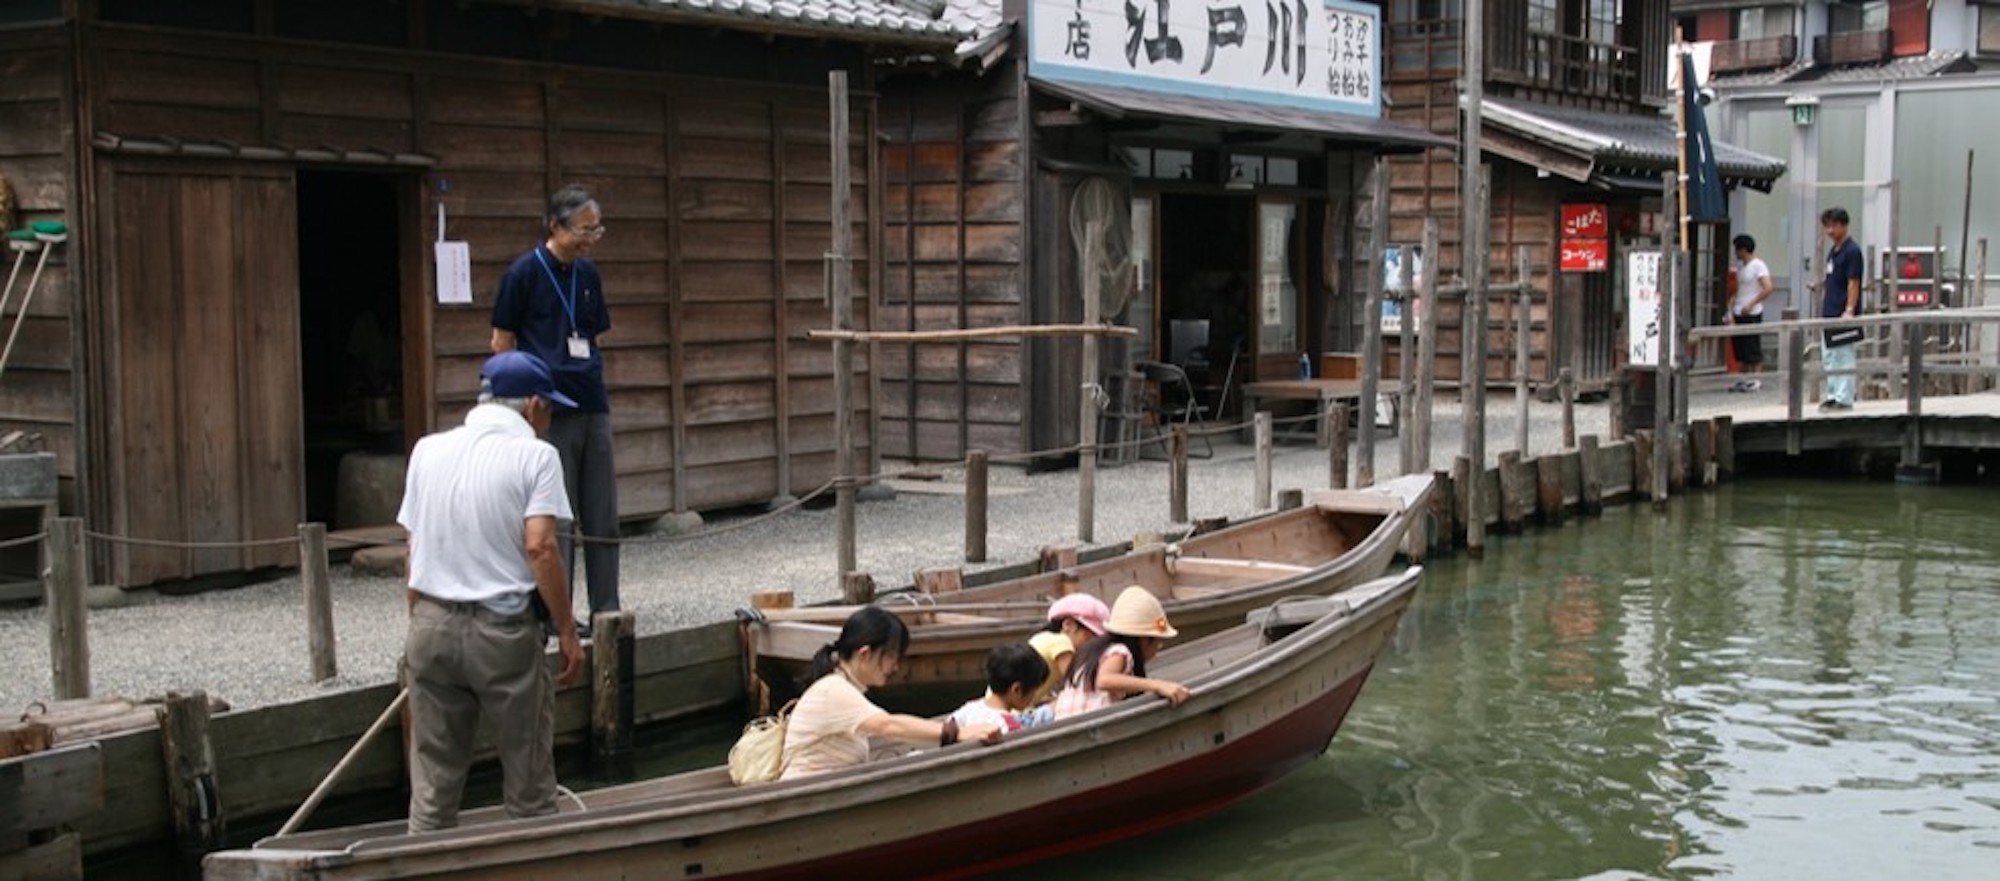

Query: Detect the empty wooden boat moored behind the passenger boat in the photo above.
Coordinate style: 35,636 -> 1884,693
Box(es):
740,475 -> 1432,705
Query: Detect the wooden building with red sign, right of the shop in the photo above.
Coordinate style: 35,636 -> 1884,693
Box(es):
1384,0 -> 1784,384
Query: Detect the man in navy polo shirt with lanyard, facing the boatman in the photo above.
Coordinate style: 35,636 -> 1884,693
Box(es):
492,184 -> 618,615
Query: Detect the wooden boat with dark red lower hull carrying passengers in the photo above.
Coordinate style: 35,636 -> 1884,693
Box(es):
204,569 -> 1420,881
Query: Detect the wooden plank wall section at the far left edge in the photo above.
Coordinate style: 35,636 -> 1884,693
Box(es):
0,30 -> 82,498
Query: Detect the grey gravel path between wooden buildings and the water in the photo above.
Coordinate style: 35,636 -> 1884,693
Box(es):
0,388 -> 1778,713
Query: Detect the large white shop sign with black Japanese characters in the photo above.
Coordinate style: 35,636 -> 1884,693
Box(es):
1028,0 -> 1382,116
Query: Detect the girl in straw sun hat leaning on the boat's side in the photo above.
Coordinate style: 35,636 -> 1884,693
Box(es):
1056,585 -> 1188,719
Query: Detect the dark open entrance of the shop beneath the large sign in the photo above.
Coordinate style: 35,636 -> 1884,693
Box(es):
1154,192 -> 1256,414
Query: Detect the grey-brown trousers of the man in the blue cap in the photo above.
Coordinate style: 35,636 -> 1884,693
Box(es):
402,599 -> 556,833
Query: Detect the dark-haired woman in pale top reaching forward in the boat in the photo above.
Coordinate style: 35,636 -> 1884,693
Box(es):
778,607 -> 1000,781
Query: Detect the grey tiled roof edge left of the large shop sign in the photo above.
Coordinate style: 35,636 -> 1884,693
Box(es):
576,0 -> 972,46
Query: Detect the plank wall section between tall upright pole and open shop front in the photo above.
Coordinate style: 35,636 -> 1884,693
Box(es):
880,62 -> 1028,461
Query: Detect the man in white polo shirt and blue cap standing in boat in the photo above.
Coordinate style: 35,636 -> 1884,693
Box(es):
396,352 -> 584,833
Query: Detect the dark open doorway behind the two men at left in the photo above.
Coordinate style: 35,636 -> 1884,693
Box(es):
298,168 -> 406,529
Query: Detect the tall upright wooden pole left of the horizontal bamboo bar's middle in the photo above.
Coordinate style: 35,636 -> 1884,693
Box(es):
826,70 -> 854,593
